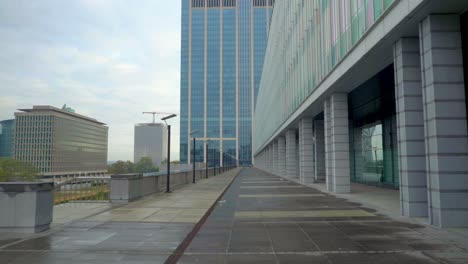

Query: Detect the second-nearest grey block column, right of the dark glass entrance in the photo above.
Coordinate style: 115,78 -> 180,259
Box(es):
393,38 -> 427,217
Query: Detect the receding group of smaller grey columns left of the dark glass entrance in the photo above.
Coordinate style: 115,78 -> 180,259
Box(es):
255,93 -> 350,193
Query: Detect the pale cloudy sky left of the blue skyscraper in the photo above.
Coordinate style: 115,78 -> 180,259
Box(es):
0,0 -> 180,160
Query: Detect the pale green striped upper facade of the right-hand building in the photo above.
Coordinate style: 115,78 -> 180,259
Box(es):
254,0 -> 396,152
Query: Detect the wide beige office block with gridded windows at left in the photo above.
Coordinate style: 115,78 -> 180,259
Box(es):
14,106 -> 109,176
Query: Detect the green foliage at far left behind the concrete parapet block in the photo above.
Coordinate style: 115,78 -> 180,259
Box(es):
0,158 -> 39,182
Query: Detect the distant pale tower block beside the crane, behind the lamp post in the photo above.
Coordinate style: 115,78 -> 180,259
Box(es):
133,123 -> 167,166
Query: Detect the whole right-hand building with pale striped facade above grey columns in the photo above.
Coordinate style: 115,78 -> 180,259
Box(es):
254,0 -> 468,227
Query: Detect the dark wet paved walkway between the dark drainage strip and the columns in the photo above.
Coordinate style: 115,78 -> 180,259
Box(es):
179,169 -> 468,264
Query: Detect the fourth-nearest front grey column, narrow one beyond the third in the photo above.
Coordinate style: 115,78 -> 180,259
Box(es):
299,118 -> 314,183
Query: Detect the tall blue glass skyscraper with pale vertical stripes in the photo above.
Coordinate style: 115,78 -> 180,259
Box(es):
180,0 -> 274,165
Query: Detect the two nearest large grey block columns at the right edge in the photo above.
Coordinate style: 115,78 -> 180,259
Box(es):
394,15 -> 468,227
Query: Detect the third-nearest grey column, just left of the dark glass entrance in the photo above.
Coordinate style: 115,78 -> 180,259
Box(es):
330,93 -> 351,193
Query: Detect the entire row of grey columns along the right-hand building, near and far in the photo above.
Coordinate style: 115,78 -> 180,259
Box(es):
256,15 -> 468,227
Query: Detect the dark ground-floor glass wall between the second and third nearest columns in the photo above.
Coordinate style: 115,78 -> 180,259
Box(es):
349,67 -> 399,188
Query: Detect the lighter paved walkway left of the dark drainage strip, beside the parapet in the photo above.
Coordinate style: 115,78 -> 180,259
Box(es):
0,169 -> 239,264
